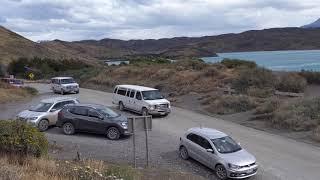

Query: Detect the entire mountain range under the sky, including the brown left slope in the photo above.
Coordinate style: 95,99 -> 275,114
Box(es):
0,24 -> 320,63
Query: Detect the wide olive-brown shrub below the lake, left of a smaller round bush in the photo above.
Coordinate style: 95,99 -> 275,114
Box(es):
232,67 -> 275,92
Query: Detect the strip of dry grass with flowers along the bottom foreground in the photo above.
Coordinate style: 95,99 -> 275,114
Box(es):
0,154 -> 202,180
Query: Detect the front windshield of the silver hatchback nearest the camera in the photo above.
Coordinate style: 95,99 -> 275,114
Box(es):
211,136 -> 242,154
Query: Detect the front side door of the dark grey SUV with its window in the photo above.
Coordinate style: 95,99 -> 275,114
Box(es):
85,108 -> 106,133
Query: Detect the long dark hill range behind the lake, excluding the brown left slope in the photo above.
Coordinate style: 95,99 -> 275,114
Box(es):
42,28 -> 320,59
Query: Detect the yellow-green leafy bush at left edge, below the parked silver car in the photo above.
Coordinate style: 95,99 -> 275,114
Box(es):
0,121 -> 48,157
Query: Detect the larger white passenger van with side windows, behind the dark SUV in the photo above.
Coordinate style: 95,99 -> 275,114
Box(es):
112,85 -> 171,116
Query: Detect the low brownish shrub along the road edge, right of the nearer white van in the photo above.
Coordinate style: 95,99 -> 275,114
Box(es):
203,95 -> 257,114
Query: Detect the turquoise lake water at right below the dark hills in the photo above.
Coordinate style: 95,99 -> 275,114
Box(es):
202,50 -> 320,71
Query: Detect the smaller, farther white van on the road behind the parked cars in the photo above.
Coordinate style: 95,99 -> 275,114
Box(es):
51,77 -> 79,95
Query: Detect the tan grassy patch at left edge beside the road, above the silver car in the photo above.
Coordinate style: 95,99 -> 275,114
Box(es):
0,82 -> 38,103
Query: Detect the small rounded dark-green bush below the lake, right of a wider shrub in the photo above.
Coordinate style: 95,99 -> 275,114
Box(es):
276,73 -> 307,93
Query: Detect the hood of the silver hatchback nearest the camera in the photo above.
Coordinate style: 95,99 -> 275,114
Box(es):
220,149 -> 256,166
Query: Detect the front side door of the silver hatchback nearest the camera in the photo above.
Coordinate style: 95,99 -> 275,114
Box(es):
198,136 -> 218,169
